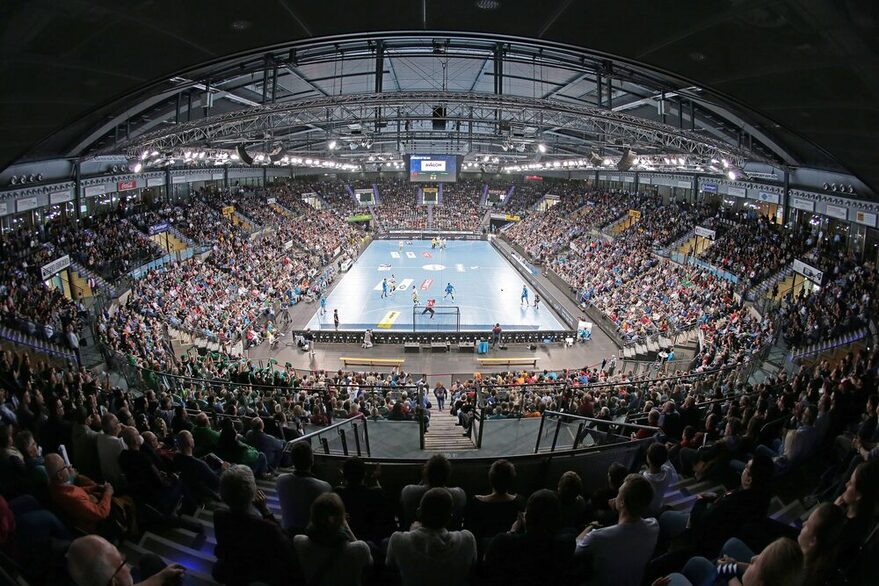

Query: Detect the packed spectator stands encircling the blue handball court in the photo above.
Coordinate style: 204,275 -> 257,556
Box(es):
0,173 -> 879,585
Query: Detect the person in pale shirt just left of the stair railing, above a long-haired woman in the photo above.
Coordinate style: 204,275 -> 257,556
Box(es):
278,442 -> 333,535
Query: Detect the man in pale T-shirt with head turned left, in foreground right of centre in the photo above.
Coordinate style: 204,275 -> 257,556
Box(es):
575,474 -> 659,586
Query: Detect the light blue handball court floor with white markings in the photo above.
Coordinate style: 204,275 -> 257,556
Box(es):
308,240 -> 565,332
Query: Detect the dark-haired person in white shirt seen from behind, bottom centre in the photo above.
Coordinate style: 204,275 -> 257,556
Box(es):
385,488 -> 476,586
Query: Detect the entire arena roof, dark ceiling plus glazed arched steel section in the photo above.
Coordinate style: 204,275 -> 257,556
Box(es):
0,0 -> 879,191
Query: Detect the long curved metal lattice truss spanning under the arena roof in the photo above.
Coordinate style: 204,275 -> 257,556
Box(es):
116,92 -> 762,162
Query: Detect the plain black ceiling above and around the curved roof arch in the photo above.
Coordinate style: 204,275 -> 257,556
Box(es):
0,0 -> 879,191
